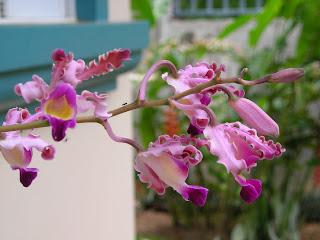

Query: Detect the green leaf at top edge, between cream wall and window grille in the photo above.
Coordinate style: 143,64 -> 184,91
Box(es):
131,0 -> 155,26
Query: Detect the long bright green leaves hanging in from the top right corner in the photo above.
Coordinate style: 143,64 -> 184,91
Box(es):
220,0 -> 320,63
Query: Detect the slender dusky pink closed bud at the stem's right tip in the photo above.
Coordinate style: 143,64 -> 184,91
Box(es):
268,68 -> 304,83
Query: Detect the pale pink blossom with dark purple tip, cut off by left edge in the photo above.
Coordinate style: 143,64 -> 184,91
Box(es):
0,108 -> 55,187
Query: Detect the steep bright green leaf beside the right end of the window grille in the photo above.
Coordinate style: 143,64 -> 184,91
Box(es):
249,0 -> 283,46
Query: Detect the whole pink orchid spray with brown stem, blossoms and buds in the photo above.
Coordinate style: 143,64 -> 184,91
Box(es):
0,49 -> 304,206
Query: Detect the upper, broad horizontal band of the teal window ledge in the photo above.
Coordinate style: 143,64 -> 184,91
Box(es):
0,21 -> 149,73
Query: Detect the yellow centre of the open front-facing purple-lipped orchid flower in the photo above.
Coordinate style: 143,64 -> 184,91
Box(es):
45,96 -> 73,120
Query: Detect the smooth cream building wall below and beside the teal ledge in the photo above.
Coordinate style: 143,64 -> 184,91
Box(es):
0,0 -> 135,240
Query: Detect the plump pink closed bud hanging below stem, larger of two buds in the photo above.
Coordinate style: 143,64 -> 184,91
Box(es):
228,98 -> 279,137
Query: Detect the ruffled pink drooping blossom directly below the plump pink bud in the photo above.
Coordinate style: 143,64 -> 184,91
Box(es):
204,122 -> 285,203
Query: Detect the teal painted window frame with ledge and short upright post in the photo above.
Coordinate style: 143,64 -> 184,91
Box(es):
0,0 -> 149,117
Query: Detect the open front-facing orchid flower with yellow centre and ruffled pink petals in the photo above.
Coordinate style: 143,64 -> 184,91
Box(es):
14,49 -> 130,141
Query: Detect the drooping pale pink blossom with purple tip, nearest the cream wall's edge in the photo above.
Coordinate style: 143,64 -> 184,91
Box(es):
135,135 -> 208,206
